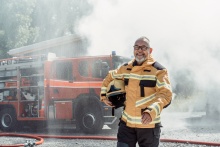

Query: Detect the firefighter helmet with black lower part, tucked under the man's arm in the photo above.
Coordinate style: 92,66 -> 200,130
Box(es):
106,79 -> 126,109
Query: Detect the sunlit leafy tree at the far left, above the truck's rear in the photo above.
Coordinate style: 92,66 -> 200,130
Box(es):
0,0 -> 36,58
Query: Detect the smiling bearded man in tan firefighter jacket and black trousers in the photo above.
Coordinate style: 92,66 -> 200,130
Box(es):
100,37 -> 172,147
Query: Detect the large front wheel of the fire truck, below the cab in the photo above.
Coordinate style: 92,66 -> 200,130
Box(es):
76,98 -> 104,134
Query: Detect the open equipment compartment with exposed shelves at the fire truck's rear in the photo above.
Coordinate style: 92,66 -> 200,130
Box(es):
0,55 -> 47,117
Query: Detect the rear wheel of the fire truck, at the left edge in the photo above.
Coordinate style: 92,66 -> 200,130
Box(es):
0,108 -> 17,132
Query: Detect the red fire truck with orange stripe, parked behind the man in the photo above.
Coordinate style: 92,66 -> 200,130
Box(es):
0,54 -> 130,133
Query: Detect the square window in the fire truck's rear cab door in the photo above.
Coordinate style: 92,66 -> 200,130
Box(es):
56,62 -> 73,81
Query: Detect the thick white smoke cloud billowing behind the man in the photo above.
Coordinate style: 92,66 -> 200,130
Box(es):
79,0 -> 220,113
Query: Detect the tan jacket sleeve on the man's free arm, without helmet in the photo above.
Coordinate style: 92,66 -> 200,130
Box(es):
145,69 -> 172,120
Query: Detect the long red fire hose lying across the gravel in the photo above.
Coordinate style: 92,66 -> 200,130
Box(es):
0,133 -> 220,147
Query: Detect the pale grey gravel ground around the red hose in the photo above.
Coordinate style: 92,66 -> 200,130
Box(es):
0,112 -> 220,147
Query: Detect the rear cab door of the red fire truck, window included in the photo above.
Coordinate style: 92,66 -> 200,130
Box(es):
49,60 -> 75,119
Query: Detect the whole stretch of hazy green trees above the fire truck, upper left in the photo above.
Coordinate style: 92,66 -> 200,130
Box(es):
0,0 -> 92,58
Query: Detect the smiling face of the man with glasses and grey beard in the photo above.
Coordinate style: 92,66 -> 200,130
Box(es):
134,40 -> 150,64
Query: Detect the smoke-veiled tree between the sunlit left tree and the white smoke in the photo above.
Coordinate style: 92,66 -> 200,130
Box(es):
32,0 -> 92,42
